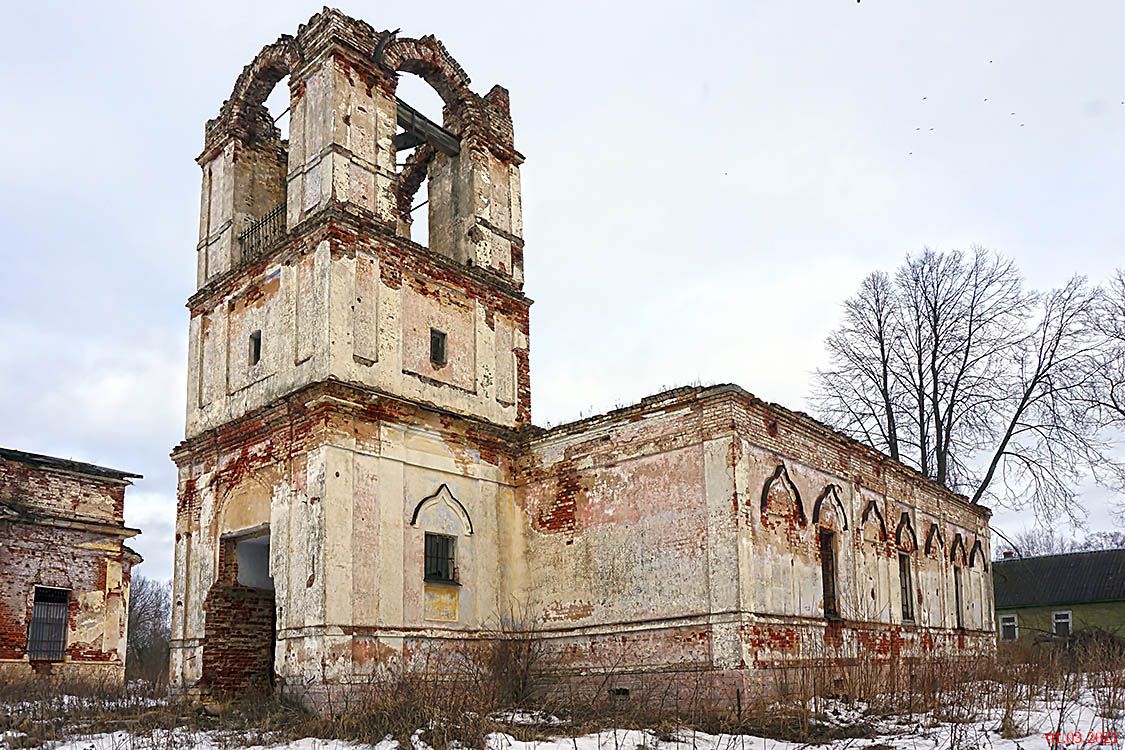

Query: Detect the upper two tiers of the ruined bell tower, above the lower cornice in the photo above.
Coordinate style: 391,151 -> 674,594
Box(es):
188,10 -> 530,435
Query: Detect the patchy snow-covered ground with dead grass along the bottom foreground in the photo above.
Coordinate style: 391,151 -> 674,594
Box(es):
0,662 -> 1125,750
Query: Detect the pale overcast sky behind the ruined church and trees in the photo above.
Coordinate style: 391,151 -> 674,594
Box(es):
0,0 -> 1125,578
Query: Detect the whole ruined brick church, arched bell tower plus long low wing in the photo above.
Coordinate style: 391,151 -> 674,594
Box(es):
171,9 -> 993,697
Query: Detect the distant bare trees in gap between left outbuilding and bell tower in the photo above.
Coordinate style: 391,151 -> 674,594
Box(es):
125,576 -> 172,684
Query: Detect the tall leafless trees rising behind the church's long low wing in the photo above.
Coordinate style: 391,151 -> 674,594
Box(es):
813,247 -> 1125,518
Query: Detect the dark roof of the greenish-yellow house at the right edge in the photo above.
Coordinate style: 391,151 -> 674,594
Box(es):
992,550 -> 1125,609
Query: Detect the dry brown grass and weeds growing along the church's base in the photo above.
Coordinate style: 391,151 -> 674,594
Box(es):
0,635 -> 1125,750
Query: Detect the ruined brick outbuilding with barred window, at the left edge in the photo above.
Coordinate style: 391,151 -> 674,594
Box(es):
0,448 -> 141,683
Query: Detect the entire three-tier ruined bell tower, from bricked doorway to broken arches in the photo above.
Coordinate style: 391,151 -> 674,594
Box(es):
172,9 -> 531,706
